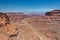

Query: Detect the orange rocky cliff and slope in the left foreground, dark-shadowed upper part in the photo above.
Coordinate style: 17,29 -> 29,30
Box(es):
0,13 -> 17,40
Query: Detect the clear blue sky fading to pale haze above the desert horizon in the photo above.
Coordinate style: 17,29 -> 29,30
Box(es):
0,0 -> 60,12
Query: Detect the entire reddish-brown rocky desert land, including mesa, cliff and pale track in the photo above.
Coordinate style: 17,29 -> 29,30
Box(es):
0,10 -> 60,40
